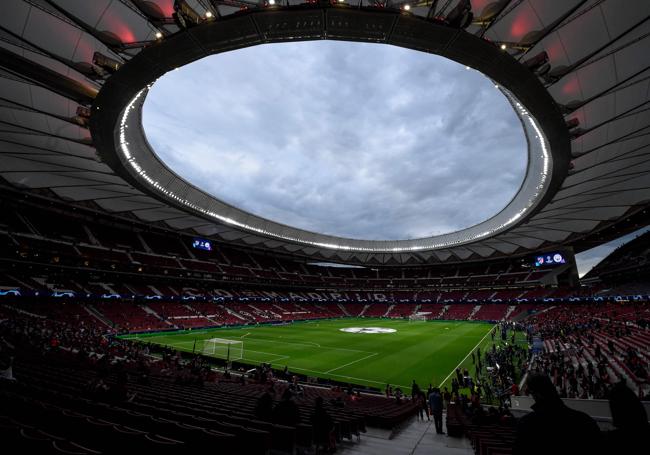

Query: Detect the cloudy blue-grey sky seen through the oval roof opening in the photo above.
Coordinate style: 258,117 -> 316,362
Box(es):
143,41 -> 526,239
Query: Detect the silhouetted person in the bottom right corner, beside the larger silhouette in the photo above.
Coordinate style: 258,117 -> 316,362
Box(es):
604,382 -> 650,453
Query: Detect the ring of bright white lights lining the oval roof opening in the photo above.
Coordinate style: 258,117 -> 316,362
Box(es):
91,8 -> 568,253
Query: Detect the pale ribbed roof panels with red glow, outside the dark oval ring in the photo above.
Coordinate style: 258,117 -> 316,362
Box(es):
0,0 -> 650,264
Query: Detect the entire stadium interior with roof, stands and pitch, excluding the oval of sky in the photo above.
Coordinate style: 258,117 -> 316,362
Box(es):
0,0 -> 650,455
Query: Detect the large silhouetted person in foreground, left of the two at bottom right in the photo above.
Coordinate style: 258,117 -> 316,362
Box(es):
512,374 -> 601,455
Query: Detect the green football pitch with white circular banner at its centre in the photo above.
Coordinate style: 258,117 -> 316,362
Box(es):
122,318 -> 494,390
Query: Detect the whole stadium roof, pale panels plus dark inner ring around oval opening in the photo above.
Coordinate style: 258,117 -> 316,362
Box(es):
0,0 -> 650,264
